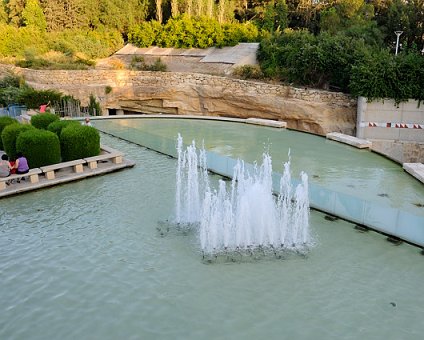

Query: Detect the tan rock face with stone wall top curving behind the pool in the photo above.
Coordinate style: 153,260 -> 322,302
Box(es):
0,66 -> 356,135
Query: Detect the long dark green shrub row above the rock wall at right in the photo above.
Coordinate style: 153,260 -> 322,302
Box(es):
258,30 -> 424,103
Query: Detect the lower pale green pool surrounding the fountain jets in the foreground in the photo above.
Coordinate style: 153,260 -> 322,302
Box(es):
0,136 -> 424,339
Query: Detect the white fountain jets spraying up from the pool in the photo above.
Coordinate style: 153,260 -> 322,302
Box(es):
175,134 -> 312,255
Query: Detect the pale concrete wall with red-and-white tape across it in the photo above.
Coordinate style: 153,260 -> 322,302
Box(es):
356,97 -> 424,163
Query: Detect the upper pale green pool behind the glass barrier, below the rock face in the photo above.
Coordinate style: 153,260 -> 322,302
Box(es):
95,118 -> 424,216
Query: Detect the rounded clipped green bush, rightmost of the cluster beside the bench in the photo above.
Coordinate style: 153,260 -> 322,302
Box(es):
60,124 -> 100,162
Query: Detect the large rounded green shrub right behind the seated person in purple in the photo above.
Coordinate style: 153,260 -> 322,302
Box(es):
16,129 -> 60,168
